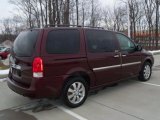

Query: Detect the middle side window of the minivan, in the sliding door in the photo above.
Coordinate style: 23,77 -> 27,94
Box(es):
86,30 -> 115,53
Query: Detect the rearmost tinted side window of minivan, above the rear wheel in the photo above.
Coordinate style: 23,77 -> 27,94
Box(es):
46,30 -> 80,54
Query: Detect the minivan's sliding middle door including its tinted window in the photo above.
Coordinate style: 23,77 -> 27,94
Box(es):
85,30 -> 121,86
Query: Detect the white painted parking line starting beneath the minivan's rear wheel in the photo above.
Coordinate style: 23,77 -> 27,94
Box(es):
57,106 -> 88,120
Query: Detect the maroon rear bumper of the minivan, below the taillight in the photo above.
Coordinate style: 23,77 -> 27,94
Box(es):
7,78 -> 59,98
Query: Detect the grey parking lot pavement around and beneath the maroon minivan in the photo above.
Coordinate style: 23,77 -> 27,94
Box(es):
0,55 -> 160,120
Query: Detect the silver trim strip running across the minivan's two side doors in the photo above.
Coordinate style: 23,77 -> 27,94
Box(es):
93,61 -> 141,71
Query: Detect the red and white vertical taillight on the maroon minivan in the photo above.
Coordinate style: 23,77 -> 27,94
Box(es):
33,57 -> 43,78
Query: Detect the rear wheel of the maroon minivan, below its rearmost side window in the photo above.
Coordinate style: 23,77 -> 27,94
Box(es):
62,77 -> 88,108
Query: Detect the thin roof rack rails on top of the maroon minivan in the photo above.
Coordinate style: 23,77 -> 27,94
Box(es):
45,24 -> 104,29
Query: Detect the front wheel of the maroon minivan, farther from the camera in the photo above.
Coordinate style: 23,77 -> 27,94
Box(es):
138,62 -> 152,82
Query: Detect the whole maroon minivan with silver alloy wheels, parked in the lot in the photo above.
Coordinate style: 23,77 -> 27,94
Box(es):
8,27 -> 154,107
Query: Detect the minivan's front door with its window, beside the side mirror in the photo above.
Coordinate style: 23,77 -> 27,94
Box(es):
116,33 -> 141,78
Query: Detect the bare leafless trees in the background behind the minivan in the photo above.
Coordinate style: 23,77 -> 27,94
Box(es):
1,0 -> 160,47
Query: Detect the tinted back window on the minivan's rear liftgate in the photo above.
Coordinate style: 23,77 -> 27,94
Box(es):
13,30 -> 38,57
